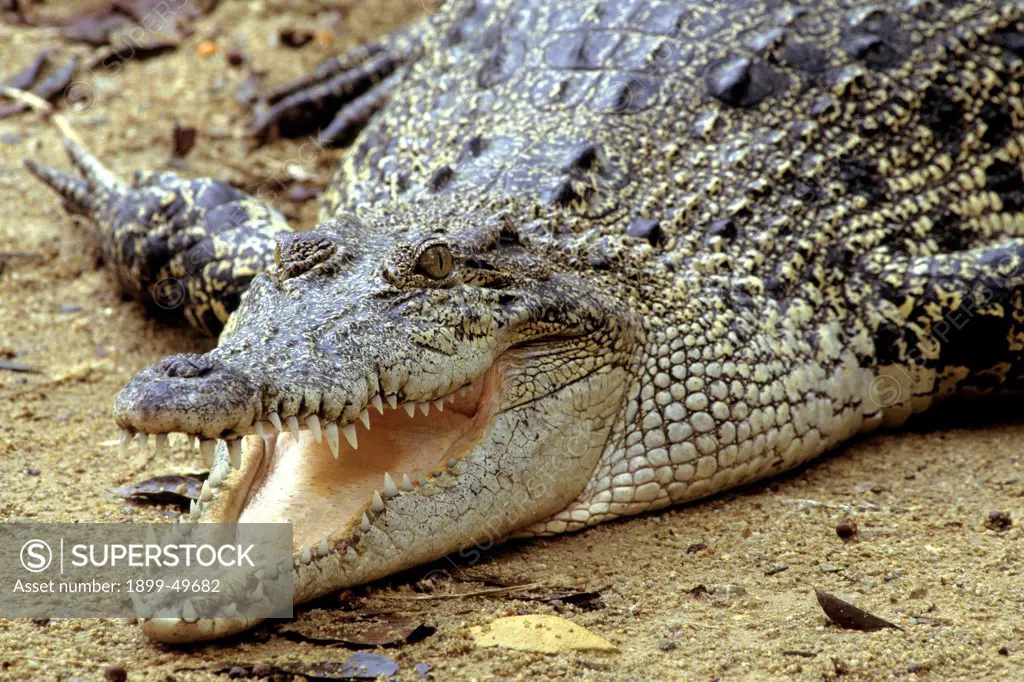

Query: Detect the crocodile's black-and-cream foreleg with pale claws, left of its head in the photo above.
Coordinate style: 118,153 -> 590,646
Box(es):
25,140 -> 290,335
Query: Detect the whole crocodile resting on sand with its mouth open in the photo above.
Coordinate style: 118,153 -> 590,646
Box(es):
19,0 -> 1024,642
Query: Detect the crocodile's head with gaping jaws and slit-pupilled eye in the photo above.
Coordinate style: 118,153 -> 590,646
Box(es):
115,199 -> 636,641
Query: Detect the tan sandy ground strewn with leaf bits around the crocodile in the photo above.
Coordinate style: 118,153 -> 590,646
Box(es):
0,0 -> 1024,680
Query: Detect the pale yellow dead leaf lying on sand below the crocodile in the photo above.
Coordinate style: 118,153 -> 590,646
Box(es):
470,613 -> 618,653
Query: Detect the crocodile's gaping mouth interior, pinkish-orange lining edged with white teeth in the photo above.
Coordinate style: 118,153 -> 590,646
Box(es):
190,367 -> 499,566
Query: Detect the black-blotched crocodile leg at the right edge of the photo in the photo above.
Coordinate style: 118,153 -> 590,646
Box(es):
865,239 -> 1024,425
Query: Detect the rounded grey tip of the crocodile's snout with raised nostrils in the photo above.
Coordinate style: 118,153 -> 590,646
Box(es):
114,354 -> 259,438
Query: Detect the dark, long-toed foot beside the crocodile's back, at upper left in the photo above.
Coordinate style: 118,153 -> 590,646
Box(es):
252,24 -> 423,146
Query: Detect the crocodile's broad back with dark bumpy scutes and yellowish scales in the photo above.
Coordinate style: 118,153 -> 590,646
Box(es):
326,0 -> 1024,289
